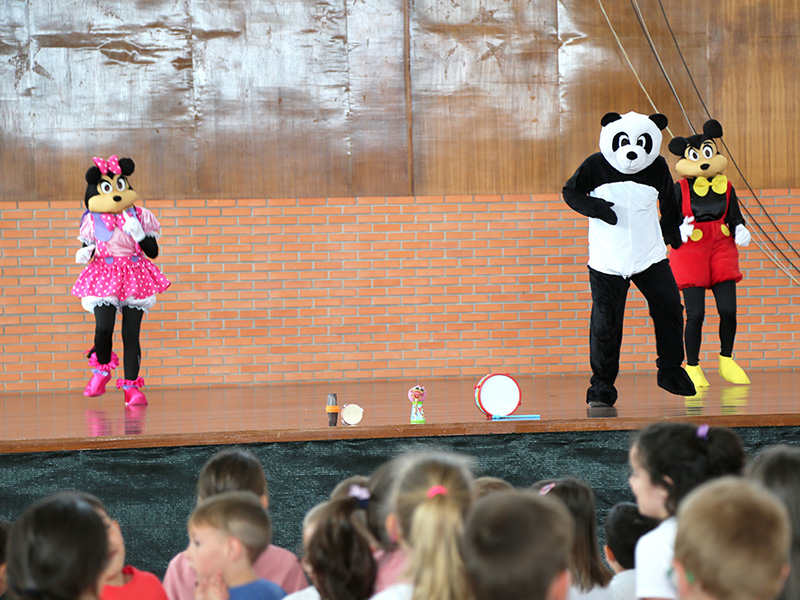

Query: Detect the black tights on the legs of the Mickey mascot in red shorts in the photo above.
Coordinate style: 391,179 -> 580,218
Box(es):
683,281 -> 736,366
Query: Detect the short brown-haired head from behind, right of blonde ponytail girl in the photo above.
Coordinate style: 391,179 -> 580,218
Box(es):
462,490 -> 574,600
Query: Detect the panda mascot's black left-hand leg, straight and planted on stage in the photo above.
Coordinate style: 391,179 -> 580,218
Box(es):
586,267 -> 630,406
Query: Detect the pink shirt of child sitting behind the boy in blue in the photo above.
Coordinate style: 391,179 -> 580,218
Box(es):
164,544 -> 308,600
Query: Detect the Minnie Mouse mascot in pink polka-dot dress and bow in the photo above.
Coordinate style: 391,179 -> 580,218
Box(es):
72,156 -> 170,406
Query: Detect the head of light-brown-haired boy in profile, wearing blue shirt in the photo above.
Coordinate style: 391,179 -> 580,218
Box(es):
186,492 -> 272,580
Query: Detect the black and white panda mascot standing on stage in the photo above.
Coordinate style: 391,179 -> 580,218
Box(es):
562,112 -> 696,407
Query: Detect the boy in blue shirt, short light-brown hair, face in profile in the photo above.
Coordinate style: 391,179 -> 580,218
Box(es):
186,492 -> 286,600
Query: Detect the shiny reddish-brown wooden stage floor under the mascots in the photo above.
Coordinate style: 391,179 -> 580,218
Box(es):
0,371 -> 800,453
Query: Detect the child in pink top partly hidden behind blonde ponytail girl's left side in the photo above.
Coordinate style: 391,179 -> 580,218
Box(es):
367,456 -> 409,594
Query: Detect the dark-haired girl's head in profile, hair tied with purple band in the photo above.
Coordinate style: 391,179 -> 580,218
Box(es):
629,423 -> 746,519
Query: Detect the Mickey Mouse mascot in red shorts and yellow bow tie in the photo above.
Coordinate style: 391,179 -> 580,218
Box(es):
669,119 -> 751,388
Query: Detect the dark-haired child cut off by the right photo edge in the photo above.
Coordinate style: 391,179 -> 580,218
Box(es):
745,444 -> 800,600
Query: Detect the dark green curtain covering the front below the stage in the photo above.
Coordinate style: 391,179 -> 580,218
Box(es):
0,427 -> 800,577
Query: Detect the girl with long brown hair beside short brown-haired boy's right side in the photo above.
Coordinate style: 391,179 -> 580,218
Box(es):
533,477 -> 612,600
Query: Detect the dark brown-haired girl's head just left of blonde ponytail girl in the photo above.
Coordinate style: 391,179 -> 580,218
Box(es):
305,498 -> 377,600
